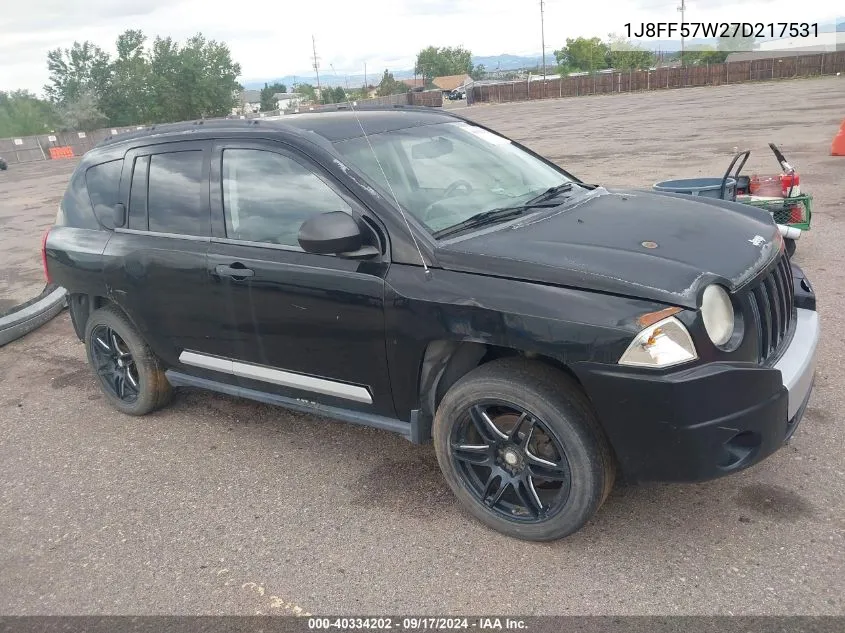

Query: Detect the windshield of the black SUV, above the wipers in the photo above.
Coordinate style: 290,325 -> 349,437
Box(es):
334,121 -> 570,233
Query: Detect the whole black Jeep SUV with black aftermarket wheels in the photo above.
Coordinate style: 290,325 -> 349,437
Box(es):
43,108 -> 819,540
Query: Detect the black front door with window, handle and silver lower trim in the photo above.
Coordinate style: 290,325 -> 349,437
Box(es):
199,141 -> 395,416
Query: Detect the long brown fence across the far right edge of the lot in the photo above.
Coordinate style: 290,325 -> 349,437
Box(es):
467,51 -> 845,105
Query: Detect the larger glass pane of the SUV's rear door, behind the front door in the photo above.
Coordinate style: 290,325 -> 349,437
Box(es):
147,150 -> 210,236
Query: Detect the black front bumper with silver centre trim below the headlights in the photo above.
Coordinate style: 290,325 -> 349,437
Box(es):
573,308 -> 819,481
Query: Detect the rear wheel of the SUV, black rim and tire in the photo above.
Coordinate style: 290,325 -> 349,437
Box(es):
85,306 -> 173,415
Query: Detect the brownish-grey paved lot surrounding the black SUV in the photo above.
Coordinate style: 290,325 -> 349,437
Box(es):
0,78 -> 845,615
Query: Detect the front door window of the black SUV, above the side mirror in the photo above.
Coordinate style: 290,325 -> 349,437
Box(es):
223,149 -> 352,247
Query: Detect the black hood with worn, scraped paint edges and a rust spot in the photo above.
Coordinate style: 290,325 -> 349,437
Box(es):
437,187 -> 782,308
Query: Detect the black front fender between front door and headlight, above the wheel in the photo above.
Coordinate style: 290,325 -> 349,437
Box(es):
385,265 -> 667,419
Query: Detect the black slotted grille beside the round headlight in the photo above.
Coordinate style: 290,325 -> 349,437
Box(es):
750,254 -> 795,363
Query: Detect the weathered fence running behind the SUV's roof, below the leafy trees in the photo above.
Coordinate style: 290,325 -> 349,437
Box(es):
0,90 -> 443,164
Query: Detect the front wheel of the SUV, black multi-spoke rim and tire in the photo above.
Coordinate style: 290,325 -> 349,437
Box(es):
433,358 -> 615,541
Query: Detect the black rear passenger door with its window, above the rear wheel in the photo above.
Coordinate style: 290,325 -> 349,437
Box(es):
104,141 -> 241,365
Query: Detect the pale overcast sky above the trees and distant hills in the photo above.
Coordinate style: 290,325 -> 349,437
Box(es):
0,0 -> 845,94
